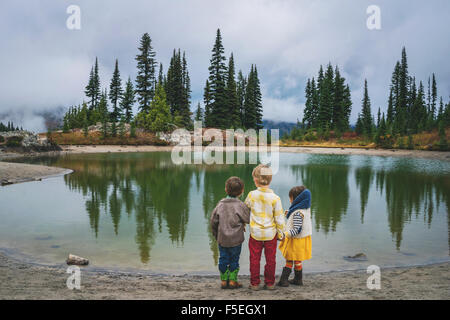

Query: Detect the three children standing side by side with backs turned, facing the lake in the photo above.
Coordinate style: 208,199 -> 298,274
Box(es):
211,164 -> 312,290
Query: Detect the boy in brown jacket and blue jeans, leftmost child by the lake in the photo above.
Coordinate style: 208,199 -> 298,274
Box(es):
210,177 -> 250,289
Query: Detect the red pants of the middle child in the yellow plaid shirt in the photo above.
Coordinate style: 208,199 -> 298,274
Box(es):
248,236 -> 277,286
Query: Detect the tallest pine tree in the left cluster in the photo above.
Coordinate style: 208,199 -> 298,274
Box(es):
136,33 -> 156,113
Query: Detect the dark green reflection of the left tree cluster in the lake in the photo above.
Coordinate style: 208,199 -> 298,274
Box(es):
43,153 -> 195,263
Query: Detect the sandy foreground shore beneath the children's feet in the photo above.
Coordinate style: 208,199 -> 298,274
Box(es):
0,254 -> 450,300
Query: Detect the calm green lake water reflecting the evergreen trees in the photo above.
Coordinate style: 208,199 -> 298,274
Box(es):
0,153 -> 450,274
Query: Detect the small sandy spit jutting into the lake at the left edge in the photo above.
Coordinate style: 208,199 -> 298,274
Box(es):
0,162 -> 71,185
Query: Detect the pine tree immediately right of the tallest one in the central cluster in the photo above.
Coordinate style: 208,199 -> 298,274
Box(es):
225,53 -> 241,128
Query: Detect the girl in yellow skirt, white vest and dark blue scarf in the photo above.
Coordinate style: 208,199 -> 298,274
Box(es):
278,186 -> 312,287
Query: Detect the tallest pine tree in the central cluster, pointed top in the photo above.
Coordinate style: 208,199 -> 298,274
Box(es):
208,29 -> 229,129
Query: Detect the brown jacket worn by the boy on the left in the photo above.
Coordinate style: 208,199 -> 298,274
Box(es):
210,198 -> 250,248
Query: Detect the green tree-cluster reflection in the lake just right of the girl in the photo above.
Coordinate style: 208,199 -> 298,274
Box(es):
291,155 -> 350,233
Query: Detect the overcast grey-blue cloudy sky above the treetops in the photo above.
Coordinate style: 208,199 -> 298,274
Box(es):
0,0 -> 450,130
